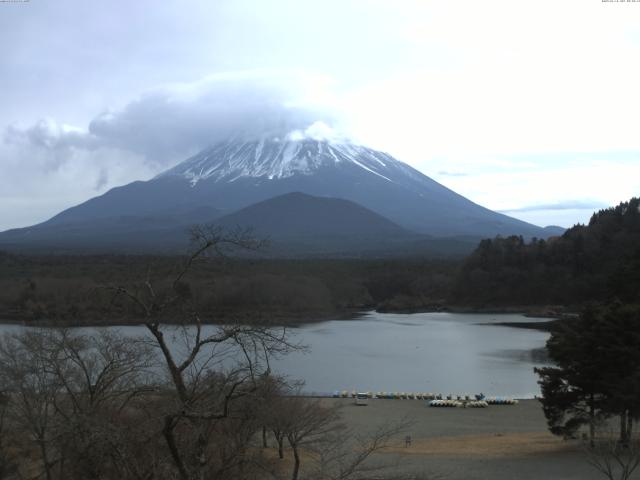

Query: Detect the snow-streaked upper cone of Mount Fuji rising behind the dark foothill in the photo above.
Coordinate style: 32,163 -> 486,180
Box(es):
32,139 -> 548,238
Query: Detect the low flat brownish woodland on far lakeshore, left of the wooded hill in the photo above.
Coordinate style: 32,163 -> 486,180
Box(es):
0,253 -> 458,325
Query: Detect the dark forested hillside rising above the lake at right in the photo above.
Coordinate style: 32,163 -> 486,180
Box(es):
452,198 -> 640,306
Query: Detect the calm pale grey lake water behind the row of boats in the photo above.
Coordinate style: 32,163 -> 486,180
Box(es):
0,312 -> 548,398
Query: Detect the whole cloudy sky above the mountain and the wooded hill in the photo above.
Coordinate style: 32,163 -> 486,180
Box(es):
0,0 -> 640,229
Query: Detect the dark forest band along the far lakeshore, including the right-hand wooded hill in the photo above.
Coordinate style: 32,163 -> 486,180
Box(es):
0,198 -> 640,325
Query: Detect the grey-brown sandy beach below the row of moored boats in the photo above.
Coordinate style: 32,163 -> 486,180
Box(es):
323,399 -> 602,480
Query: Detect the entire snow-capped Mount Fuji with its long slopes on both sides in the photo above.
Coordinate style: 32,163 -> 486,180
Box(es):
0,136 -> 558,255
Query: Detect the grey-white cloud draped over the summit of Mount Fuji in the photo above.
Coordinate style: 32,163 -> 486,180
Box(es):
89,71 -> 342,165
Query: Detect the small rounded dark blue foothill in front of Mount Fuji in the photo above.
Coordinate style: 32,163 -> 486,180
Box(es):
216,192 -> 479,257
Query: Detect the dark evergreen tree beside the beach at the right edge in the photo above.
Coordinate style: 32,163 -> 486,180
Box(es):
536,304 -> 640,443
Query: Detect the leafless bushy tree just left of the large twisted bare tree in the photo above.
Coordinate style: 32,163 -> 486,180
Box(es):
46,330 -> 153,478
